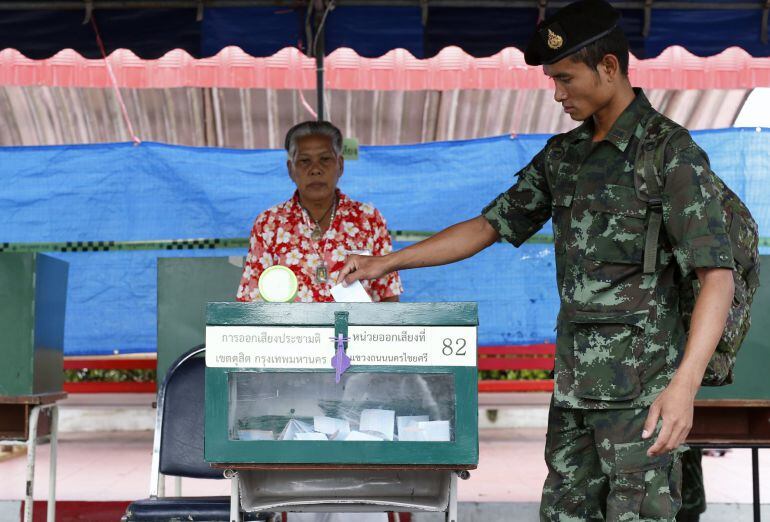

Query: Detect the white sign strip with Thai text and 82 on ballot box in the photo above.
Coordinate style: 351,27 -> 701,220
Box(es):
206,326 -> 476,369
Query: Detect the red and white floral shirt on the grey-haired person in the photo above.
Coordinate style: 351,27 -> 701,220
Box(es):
236,190 -> 404,303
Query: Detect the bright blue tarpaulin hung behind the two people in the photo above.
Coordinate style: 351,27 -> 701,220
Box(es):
0,129 -> 770,355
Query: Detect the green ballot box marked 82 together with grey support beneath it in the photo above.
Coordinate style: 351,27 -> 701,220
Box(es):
204,303 -> 478,511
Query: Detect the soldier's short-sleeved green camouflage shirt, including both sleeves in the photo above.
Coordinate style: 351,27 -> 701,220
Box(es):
483,89 -> 733,409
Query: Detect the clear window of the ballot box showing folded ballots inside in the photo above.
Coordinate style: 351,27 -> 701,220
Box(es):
228,371 -> 456,443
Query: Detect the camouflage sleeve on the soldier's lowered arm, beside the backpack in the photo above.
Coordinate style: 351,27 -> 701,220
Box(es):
662,133 -> 733,276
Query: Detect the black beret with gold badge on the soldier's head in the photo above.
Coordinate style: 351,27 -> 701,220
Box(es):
524,0 -> 620,65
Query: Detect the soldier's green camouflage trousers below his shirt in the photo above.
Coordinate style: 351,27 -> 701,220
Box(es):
540,396 -> 682,522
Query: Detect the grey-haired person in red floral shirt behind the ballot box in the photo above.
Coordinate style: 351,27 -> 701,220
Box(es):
237,121 -> 403,303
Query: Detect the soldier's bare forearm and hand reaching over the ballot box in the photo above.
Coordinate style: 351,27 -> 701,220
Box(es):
338,216 -> 500,284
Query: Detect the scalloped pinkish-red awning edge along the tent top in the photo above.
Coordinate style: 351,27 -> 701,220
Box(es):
0,47 -> 770,91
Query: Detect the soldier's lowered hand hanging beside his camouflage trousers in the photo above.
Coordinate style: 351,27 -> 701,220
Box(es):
642,379 -> 695,457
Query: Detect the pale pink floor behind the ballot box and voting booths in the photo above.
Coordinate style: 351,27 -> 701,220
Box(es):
0,428 -> 770,504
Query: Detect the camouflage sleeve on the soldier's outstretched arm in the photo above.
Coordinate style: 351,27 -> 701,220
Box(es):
481,145 -> 551,246
